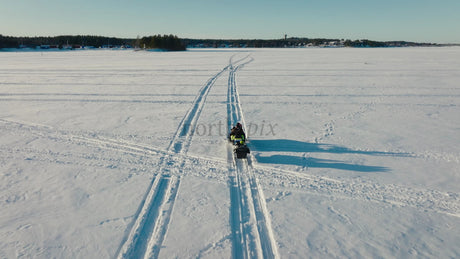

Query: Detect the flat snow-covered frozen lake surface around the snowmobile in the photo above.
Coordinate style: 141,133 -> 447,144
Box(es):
0,47 -> 460,258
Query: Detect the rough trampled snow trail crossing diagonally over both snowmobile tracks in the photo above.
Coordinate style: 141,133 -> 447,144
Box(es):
0,119 -> 460,220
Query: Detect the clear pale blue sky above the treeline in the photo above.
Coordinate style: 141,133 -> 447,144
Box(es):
0,0 -> 460,43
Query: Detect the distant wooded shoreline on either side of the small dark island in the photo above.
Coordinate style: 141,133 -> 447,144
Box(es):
0,35 -> 460,51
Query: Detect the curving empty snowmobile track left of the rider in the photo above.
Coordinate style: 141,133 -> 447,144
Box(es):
118,63 -> 228,258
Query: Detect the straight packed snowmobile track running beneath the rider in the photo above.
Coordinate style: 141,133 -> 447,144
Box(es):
227,56 -> 279,258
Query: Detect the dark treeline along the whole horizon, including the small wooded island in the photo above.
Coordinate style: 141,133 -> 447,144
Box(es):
0,34 -> 438,51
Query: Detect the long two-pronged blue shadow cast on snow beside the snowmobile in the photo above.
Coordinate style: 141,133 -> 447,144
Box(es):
250,139 -> 410,172
